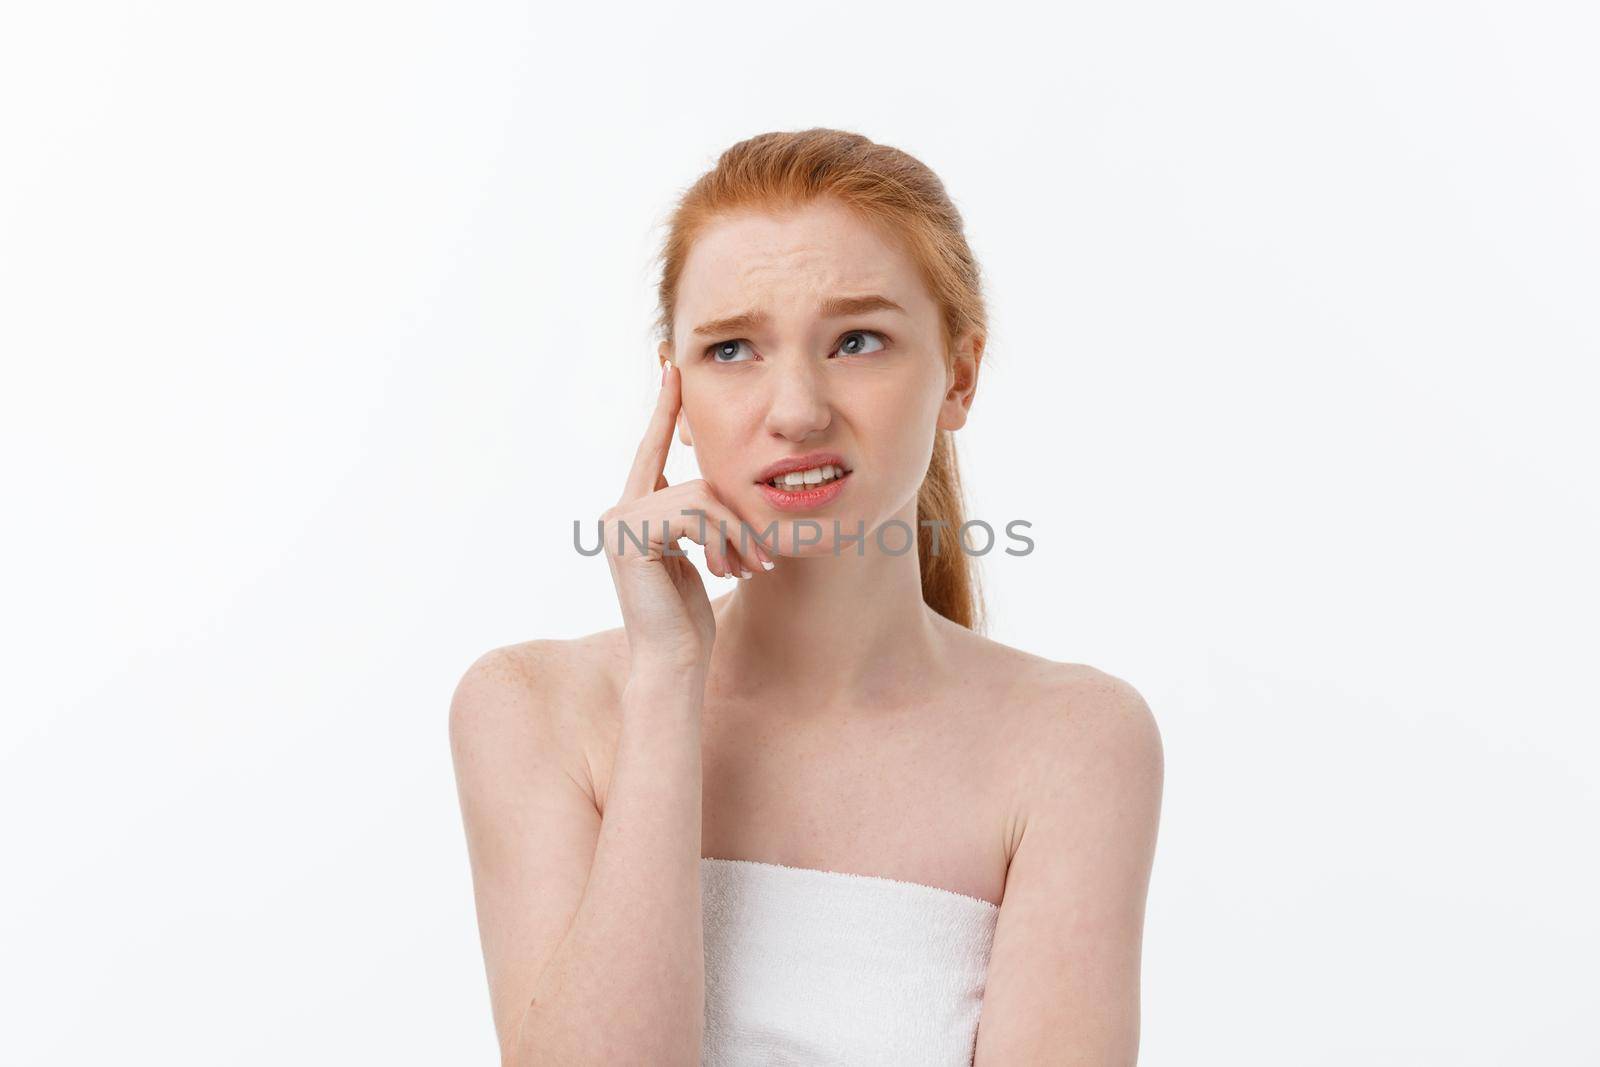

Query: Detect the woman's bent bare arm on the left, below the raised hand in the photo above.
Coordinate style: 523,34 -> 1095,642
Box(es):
450,641 -> 706,1067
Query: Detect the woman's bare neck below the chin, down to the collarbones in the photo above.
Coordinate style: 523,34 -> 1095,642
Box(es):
707,498 -> 942,715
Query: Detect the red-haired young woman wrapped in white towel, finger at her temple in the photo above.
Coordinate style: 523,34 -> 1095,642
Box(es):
450,130 -> 1163,1067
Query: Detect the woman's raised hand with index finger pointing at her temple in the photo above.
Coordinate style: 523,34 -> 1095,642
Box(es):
600,362 -> 770,667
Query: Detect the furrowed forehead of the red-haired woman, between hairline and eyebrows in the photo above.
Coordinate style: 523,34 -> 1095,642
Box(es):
677,200 -> 933,328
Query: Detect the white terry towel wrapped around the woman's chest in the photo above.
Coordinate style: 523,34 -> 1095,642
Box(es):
701,859 -> 1000,1067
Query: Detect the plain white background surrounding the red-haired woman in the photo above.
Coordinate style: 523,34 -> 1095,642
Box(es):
0,0 -> 1600,1065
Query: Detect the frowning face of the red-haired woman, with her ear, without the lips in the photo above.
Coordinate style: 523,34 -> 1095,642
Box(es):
661,200 -> 981,555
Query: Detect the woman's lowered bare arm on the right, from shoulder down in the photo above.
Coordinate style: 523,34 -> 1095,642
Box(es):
973,665 -> 1163,1067
